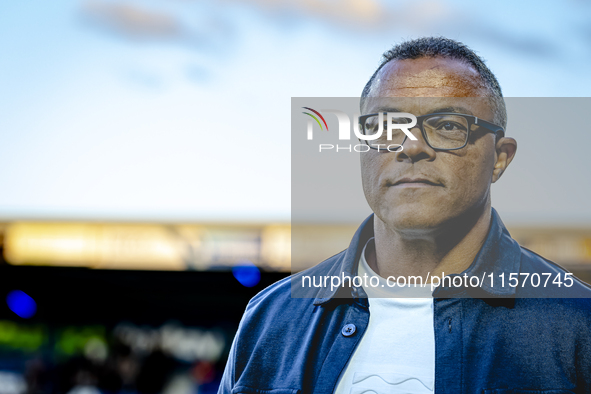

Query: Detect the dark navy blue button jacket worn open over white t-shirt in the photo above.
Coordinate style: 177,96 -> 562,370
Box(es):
219,209 -> 591,394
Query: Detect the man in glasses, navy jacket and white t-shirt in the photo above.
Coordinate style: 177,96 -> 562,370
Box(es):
219,38 -> 591,394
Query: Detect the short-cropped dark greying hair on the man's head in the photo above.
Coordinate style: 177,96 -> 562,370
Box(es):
361,37 -> 507,128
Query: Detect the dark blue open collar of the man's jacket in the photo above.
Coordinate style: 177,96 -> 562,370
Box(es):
314,208 -> 521,305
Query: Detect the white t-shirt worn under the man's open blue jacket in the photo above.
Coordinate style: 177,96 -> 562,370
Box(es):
335,240 -> 435,394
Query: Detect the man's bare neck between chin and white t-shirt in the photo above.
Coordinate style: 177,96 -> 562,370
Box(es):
366,204 -> 491,281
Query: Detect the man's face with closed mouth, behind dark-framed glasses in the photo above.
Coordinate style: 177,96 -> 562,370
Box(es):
361,58 -> 497,233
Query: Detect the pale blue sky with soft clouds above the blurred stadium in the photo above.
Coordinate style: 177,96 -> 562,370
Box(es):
0,0 -> 591,224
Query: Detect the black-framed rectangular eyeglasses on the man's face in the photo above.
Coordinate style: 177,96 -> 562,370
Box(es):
359,112 -> 505,150
